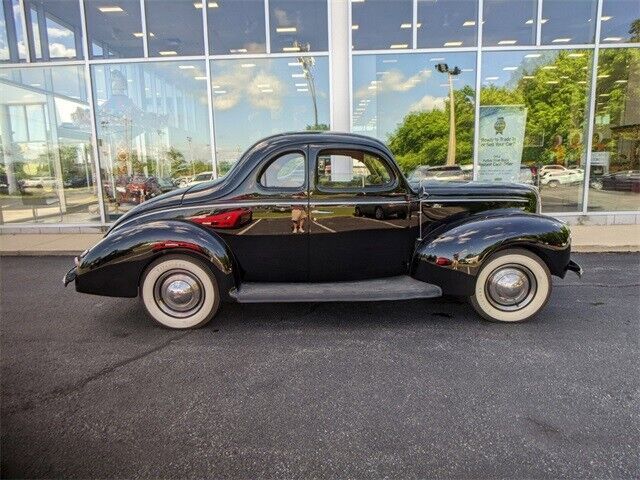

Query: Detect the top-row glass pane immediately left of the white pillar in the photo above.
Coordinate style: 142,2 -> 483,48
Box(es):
269,0 -> 329,53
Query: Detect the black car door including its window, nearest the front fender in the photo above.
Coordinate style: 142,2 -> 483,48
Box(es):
308,144 -> 412,282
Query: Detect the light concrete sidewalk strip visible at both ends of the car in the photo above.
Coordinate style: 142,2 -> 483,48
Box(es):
0,225 -> 640,255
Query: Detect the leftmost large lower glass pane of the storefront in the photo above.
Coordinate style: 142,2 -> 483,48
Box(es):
0,66 -> 100,224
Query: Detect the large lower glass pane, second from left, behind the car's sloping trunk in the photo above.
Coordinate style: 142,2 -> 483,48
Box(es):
91,61 -> 213,221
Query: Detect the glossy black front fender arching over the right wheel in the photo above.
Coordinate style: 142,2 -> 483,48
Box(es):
411,212 -> 571,296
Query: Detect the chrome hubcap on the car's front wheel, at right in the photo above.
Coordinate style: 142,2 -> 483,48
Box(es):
486,265 -> 537,311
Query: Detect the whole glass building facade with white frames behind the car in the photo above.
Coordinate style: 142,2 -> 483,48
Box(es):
0,0 -> 640,229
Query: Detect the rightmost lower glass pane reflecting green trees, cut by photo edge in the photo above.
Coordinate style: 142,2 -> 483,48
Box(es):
588,48 -> 640,211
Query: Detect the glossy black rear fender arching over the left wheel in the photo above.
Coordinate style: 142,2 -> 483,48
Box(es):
75,220 -> 238,299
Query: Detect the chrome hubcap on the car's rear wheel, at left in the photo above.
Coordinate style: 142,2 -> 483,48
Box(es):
154,270 -> 204,318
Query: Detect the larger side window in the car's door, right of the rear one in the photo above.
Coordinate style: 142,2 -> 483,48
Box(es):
317,150 -> 393,189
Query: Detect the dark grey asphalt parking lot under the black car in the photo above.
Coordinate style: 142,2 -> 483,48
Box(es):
0,254 -> 640,479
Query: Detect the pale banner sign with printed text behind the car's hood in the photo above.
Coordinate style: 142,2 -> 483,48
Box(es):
477,105 -> 527,182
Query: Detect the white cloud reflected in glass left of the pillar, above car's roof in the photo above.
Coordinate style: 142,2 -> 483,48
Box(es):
212,65 -> 285,110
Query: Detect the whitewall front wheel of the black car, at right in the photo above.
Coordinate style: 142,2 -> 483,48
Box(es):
470,249 -> 551,322
